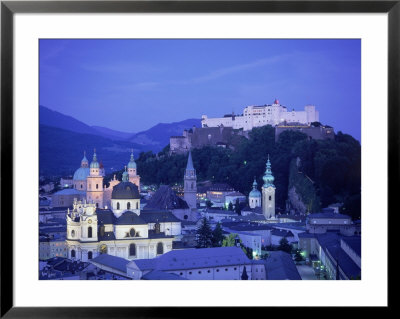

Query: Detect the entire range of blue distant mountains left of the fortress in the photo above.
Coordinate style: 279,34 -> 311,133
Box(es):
39,105 -> 201,175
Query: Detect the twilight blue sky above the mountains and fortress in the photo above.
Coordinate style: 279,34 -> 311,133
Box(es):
40,40 -> 361,140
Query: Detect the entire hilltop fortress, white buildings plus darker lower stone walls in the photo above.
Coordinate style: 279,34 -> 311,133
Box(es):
170,99 -> 335,154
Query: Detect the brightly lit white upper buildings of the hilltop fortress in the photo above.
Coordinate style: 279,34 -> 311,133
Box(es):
201,99 -> 319,131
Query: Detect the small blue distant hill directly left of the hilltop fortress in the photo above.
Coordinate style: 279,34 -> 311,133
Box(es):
129,119 -> 201,152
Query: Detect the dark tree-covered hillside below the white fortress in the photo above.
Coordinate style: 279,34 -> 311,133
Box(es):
137,125 -> 361,219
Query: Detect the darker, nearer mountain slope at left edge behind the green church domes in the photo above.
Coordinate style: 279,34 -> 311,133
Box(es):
39,125 -> 149,175
